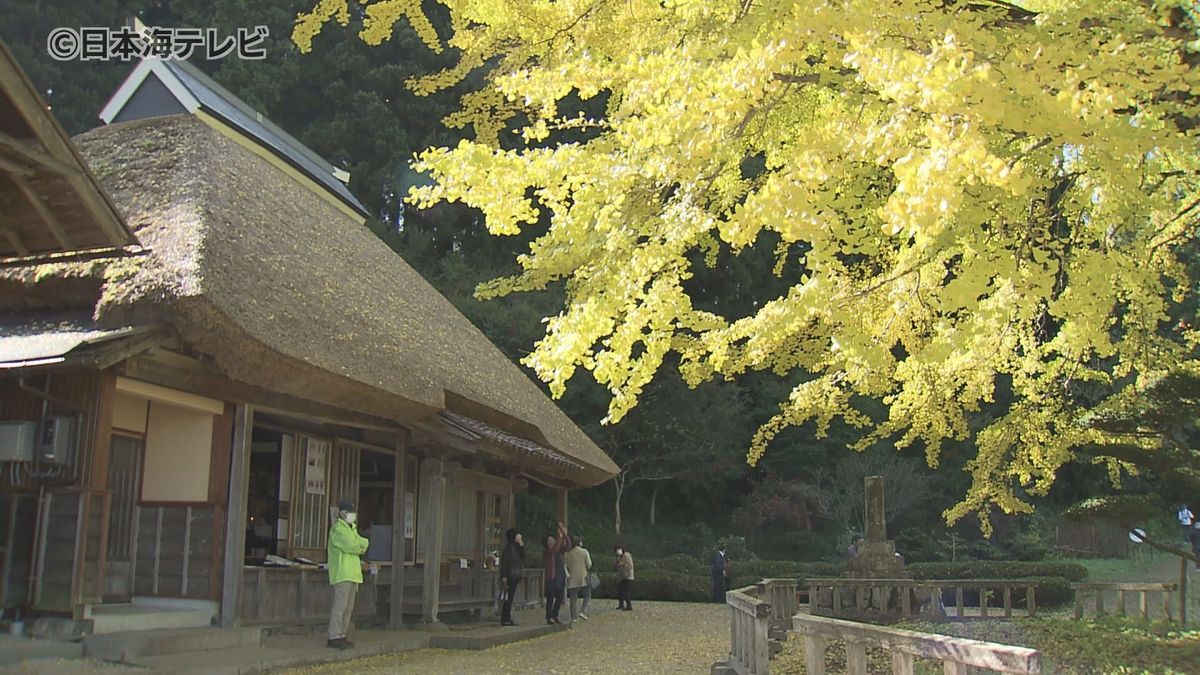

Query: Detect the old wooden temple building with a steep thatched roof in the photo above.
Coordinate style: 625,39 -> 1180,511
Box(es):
0,44 -> 617,632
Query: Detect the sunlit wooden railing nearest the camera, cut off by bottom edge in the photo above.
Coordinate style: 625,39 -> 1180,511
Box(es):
792,614 -> 1042,675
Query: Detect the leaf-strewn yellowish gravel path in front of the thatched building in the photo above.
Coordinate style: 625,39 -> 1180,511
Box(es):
287,601 -> 730,675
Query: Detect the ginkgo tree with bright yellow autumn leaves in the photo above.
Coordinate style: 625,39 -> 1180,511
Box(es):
293,0 -> 1200,530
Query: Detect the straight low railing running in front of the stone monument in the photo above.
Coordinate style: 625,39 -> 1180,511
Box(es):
806,579 -> 1038,619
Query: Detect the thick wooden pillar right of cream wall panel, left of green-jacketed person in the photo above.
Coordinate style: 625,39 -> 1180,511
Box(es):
221,404 -> 254,628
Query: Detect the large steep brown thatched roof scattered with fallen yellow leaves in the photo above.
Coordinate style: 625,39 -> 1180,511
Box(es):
68,115 -> 617,485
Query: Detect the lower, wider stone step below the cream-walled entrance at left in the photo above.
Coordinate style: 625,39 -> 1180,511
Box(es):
83,628 -> 263,662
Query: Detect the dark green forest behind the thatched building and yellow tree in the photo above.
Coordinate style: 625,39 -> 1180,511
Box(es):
0,0 -> 1183,561
